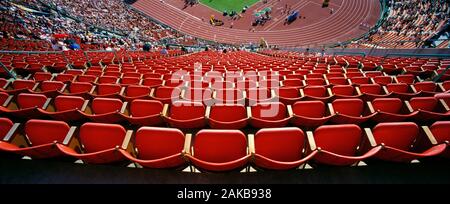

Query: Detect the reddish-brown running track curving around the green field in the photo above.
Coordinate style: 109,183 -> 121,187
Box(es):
132,0 -> 380,47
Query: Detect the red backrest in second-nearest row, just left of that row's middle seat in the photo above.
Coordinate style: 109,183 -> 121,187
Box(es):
170,101 -> 206,120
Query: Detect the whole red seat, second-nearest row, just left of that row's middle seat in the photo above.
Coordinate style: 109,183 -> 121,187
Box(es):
164,101 -> 206,128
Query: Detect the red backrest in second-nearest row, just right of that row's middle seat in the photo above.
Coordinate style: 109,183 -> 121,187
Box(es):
251,102 -> 287,120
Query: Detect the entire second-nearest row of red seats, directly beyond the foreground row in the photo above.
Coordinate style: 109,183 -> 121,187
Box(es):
0,93 -> 450,129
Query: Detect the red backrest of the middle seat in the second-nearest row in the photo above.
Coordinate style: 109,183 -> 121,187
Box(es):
209,104 -> 247,122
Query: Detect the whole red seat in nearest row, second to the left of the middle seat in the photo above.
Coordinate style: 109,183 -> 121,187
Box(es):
57,123 -> 132,164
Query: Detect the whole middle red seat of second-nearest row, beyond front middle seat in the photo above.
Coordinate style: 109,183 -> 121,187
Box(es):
208,104 -> 248,129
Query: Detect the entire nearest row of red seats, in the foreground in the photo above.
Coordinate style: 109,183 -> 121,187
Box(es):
0,118 -> 450,172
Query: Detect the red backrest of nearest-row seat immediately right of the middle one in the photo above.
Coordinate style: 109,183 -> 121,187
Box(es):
255,127 -> 305,162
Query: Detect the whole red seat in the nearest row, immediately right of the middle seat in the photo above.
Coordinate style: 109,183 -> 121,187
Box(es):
253,127 -> 318,170
